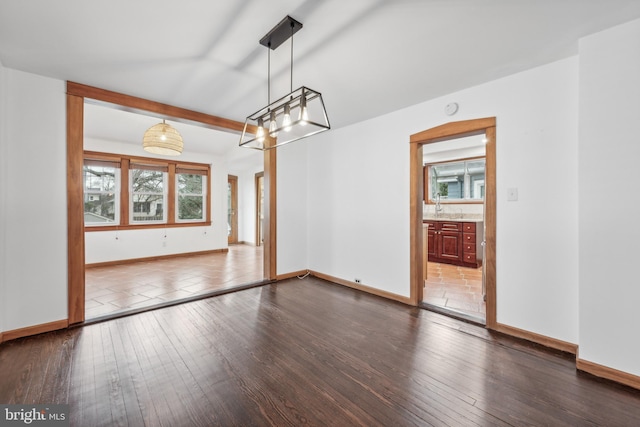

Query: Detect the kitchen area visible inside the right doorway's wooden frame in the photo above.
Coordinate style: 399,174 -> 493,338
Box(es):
422,135 -> 486,324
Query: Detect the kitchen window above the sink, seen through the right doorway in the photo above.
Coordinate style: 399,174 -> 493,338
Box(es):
427,158 -> 485,203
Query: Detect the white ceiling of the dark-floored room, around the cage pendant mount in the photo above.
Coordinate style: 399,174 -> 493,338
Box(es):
0,0 -> 640,155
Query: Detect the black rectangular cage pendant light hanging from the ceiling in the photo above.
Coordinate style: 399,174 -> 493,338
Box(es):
239,16 -> 331,150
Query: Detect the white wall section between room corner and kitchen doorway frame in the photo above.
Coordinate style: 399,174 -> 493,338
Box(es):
308,112 -> 411,295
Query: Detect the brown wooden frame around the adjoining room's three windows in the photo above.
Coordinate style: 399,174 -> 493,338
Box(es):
83,151 -> 212,231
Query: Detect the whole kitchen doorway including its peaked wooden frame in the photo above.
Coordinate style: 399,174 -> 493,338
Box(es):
410,117 -> 497,329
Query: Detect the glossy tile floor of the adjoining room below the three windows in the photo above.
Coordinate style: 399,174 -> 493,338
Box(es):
85,244 -> 263,320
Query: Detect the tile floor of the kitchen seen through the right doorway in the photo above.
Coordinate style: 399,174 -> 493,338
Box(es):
422,262 -> 486,323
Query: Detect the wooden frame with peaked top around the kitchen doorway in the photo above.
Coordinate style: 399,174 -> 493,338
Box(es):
409,117 -> 497,329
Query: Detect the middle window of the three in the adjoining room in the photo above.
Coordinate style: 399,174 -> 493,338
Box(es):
129,164 -> 167,224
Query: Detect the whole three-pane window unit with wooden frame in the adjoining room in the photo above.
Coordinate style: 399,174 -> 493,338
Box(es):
83,151 -> 211,231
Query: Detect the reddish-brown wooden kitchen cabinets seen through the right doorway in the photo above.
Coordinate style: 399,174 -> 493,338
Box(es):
424,220 -> 483,268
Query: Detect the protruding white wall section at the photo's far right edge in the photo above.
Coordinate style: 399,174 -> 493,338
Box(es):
579,20 -> 640,375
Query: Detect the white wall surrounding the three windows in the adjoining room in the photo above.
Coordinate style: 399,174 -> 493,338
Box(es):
84,138 -> 227,264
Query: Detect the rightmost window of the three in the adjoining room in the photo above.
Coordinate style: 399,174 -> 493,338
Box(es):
176,169 -> 207,222
